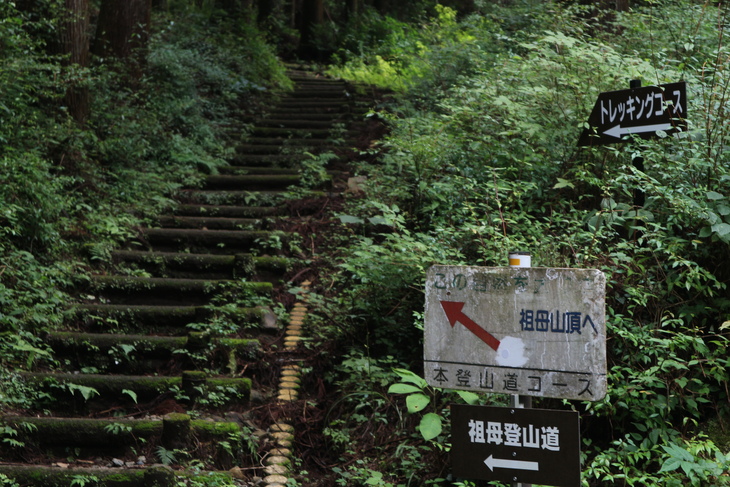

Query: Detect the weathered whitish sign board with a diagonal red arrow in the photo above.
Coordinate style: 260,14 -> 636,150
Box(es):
424,266 -> 606,401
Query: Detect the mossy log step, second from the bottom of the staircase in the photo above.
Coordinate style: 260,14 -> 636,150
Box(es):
0,413 -> 242,449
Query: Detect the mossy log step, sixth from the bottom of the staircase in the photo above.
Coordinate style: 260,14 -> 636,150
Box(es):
87,276 -> 273,305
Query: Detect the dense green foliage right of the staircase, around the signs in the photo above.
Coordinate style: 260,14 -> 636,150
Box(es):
314,0 -> 730,486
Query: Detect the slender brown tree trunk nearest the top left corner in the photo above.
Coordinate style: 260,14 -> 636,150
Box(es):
59,0 -> 89,123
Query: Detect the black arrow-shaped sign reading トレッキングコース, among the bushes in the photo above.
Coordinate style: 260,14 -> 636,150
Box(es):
578,81 -> 687,146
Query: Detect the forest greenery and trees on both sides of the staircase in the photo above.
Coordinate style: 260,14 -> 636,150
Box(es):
0,0 -> 730,486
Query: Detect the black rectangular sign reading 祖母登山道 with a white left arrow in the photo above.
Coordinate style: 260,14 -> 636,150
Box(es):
451,405 -> 581,487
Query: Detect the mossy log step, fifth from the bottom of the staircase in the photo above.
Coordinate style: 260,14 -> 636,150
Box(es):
71,304 -> 264,334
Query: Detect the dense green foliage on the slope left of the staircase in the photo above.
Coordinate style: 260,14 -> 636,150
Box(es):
0,0 -> 289,378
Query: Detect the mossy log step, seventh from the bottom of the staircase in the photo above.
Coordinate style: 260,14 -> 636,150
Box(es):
112,250 -> 292,280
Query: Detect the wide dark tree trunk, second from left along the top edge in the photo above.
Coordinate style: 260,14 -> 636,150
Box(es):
93,0 -> 152,69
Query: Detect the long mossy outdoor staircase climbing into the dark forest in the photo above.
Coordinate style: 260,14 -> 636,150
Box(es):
0,70 -> 376,487
